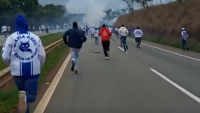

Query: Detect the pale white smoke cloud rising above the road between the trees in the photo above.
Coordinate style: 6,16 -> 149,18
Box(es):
66,0 -> 125,25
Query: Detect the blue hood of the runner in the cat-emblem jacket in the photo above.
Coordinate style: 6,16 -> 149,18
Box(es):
15,15 -> 29,34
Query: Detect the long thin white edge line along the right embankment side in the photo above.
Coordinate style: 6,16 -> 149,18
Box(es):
129,39 -> 200,62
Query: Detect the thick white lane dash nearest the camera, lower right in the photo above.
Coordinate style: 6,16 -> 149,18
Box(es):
150,68 -> 200,103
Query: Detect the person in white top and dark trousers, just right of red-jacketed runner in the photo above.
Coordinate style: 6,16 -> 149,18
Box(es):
118,25 -> 128,53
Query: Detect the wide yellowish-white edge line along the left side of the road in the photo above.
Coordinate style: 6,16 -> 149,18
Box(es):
33,54 -> 71,113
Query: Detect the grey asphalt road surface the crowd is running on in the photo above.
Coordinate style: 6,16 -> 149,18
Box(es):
45,38 -> 200,113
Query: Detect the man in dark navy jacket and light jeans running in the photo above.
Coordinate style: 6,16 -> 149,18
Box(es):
63,22 -> 87,74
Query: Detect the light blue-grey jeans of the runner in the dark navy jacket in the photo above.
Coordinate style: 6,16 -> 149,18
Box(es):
70,47 -> 80,70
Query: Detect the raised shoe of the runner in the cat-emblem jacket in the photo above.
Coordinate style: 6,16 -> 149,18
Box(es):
18,91 -> 27,113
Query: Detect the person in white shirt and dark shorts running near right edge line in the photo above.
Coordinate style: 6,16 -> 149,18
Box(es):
133,27 -> 143,48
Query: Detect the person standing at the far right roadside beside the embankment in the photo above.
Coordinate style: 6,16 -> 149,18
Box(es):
181,28 -> 189,51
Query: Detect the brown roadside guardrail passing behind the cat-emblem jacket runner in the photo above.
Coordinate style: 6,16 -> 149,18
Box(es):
0,39 -> 63,90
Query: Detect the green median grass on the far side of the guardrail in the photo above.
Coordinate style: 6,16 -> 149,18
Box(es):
0,33 -> 63,70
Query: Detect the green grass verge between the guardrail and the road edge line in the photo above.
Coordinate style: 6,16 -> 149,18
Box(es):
0,46 -> 67,113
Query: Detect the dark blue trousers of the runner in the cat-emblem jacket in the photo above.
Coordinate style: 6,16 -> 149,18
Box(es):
13,75 -> 39,113
